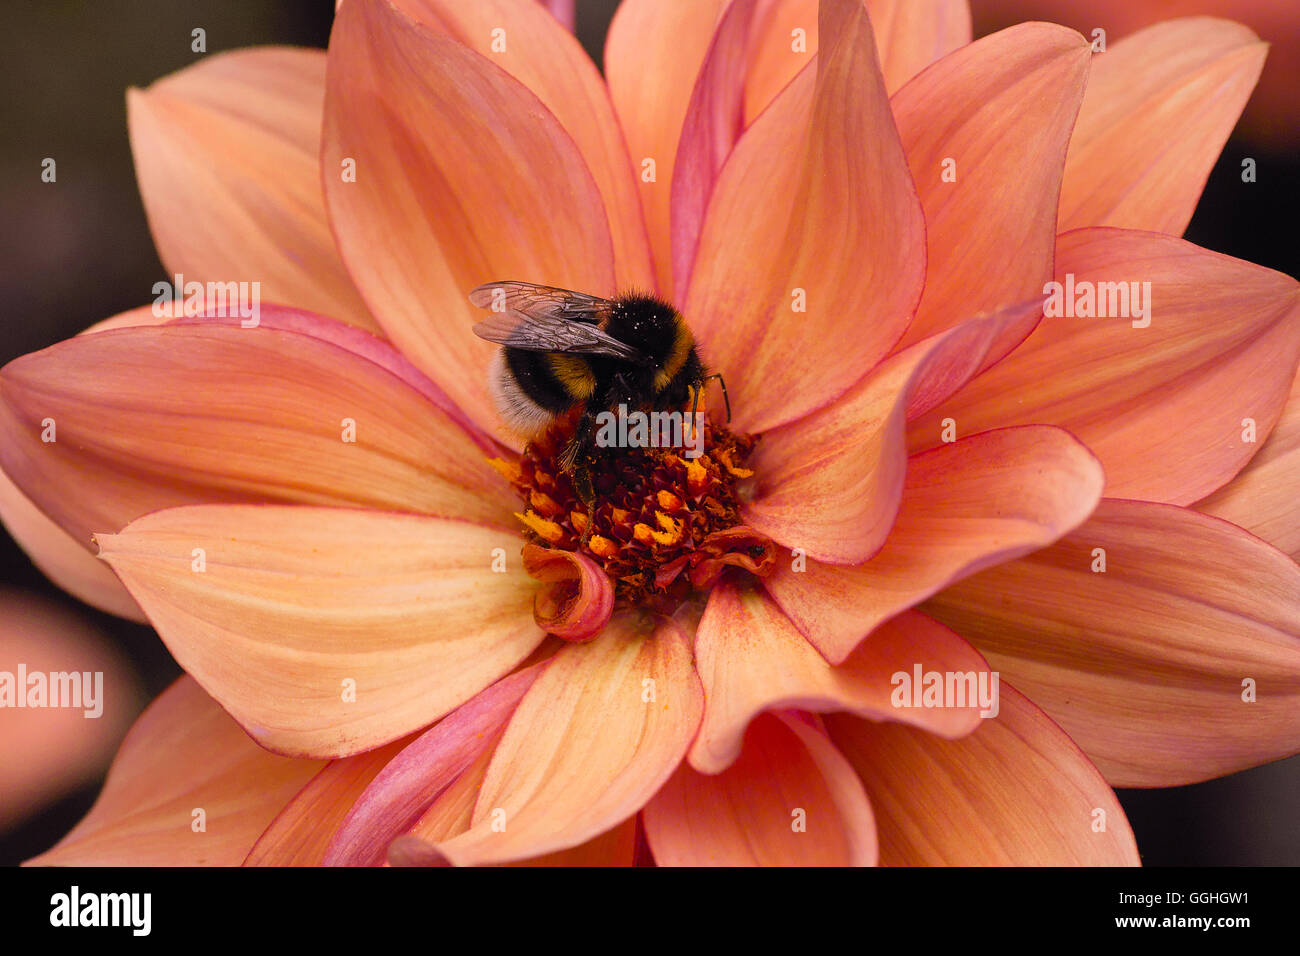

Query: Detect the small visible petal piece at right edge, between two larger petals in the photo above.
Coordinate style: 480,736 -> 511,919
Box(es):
1196,378 -> 1300,561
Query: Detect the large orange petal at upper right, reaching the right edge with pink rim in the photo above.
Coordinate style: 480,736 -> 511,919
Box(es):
910,229 -> 1300,505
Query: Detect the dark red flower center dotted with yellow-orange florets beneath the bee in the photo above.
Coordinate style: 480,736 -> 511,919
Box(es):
488,411 -> 776,629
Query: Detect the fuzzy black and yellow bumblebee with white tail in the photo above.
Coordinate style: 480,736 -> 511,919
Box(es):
469,282 -> 731,506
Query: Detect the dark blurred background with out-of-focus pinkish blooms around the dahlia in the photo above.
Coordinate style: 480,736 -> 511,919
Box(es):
0,0 -> 1300,866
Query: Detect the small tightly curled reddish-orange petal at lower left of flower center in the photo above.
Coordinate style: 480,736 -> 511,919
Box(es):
524,544 -> 614,644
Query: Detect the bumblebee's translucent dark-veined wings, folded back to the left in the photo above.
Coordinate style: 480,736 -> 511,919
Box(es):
469,282 -> 649,364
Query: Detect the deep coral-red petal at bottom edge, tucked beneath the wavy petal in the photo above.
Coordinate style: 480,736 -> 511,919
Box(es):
645,714 -> 876,866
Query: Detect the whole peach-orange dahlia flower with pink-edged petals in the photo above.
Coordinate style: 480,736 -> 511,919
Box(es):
0,0 -> 1300,865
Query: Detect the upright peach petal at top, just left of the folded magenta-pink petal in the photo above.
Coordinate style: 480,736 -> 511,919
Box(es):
605,0 -> 729,300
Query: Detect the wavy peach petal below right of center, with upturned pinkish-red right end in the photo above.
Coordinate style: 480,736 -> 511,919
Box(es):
690,581 -> 988,774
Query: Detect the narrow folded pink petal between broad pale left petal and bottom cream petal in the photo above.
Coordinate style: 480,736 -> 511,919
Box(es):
324,667 -> 540,866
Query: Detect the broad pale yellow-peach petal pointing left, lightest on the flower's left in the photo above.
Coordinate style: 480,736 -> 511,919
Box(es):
96,505 -> 542,757
